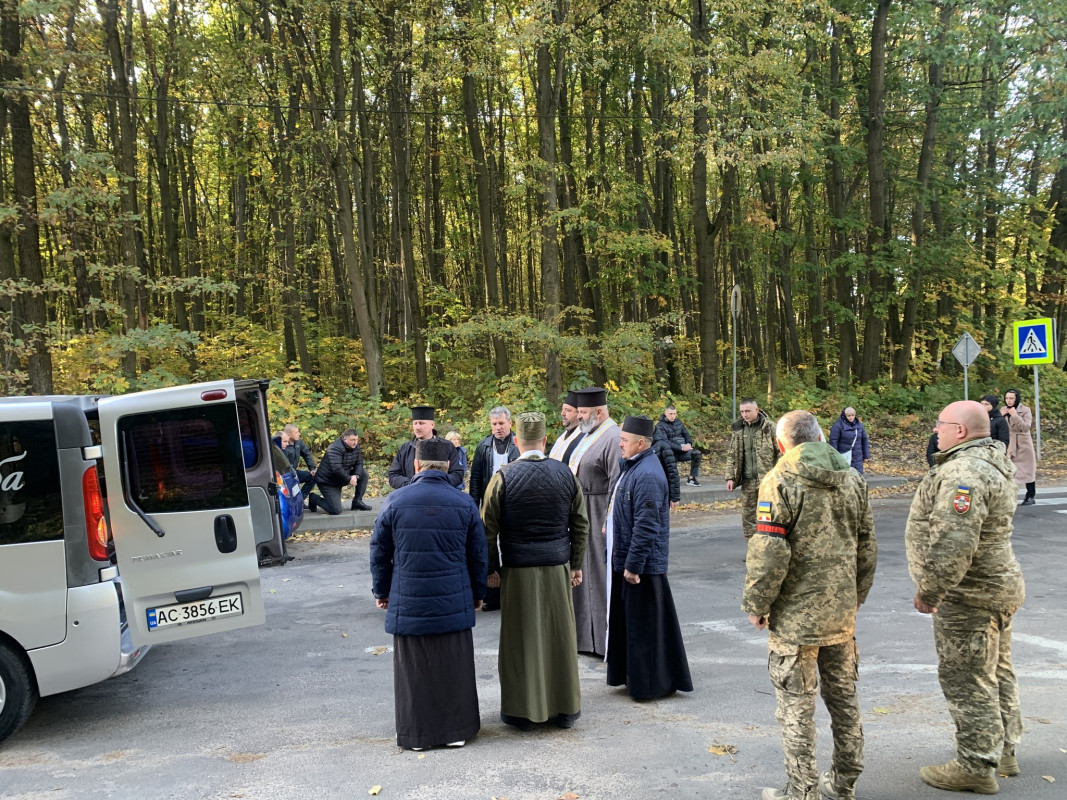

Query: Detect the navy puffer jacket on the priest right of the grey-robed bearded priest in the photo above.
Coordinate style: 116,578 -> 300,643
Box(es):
611,448 -> 670,575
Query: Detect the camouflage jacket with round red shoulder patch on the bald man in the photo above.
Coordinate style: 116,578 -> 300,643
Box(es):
904,437 -> 1025,613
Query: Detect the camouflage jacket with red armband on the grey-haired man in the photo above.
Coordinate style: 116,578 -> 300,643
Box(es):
740,442 -> 878,645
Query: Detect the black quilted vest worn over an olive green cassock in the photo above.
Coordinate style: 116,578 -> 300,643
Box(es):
499,459 -> 578,566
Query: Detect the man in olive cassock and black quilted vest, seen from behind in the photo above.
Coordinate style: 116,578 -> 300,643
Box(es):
481,412 -> 589,731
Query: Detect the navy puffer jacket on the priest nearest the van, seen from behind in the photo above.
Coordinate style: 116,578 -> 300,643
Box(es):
370,469 -> 489,636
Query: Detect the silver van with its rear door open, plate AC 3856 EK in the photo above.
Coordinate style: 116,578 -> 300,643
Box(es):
0,381 -> 287,741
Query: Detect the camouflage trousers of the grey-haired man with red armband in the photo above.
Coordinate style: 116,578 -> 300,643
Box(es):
767,636 -> 863,800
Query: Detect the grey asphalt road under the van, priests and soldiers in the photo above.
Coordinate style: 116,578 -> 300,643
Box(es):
0,491 -> 1067,800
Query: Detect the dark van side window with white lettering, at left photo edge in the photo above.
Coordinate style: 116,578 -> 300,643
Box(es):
0,419 -> 63,545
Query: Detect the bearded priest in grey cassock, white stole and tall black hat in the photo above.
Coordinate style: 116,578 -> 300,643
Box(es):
568,387 -> 619,658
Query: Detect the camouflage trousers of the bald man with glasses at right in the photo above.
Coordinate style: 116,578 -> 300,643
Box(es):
934,603 -> 1022,774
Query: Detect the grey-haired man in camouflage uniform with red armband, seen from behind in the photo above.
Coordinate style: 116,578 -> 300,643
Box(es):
742,411 -> 878,800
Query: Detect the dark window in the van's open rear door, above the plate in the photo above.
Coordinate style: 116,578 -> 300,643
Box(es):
118,403 -> 249,514
